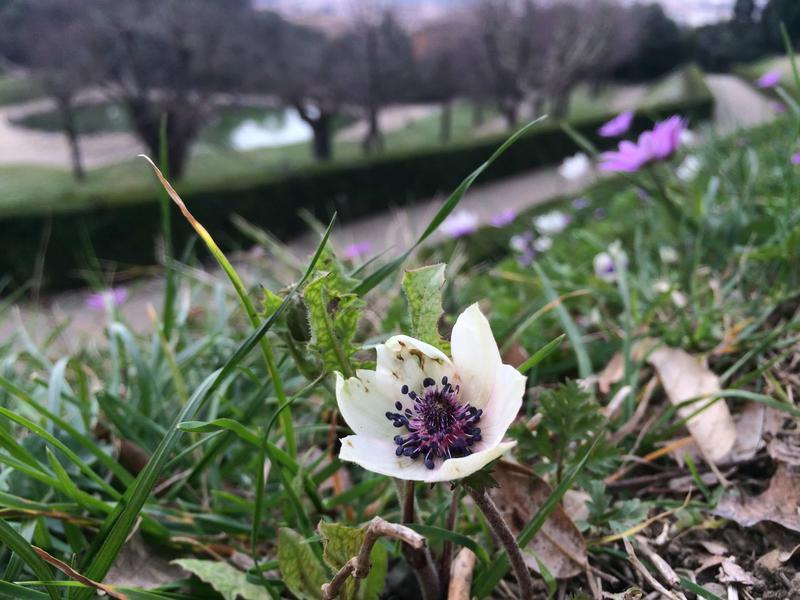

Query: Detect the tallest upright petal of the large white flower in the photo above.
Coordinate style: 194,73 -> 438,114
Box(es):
450,304 -> 502,408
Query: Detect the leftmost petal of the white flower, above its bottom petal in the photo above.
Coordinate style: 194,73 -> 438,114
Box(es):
336,370 -> 401,440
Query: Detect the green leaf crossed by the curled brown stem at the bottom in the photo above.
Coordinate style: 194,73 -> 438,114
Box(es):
319,521 -> 388,600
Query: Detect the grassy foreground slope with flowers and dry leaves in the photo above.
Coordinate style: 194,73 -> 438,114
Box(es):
0,90 -> 800,600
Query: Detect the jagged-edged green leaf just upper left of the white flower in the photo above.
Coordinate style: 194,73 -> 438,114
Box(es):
305,274 -> 364,373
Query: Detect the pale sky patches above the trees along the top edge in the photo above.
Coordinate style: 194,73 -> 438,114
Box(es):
254,0 -> 748,26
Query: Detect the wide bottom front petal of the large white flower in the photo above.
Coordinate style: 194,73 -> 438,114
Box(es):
339,435 -> 516,483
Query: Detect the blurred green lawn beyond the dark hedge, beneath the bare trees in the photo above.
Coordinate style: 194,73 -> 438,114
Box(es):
0,72 -> 686,215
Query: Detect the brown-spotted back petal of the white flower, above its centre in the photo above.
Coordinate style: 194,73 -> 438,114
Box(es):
376,335 -> 454,399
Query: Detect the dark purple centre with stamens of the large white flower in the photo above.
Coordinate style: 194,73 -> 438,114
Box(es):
386,377 -> 483,469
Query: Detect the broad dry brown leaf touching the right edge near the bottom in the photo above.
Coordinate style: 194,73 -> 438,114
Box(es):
714,464 -> 800,532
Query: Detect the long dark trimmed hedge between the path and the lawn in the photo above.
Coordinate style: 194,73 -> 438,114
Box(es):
0,70 -> 713,288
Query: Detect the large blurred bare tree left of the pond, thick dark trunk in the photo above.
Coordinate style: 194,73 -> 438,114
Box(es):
81,0 -> 252,177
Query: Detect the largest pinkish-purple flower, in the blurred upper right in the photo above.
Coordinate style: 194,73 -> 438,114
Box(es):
600,115 -> 685,173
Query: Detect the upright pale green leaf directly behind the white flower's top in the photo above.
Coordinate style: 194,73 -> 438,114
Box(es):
403,263 -> 450,354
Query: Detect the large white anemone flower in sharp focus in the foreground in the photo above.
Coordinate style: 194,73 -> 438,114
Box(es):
336,304 -> 526,482
